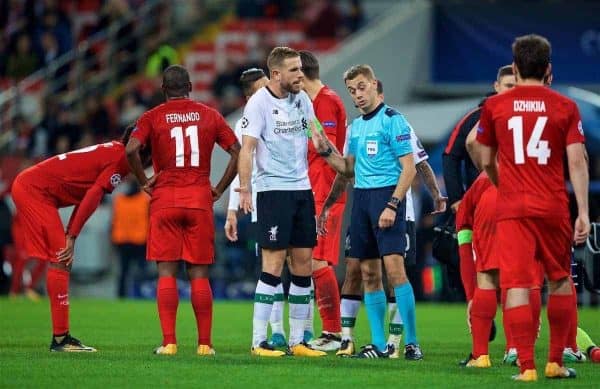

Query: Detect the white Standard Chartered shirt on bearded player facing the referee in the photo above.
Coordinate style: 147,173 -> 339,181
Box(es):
241,87 -> 315,192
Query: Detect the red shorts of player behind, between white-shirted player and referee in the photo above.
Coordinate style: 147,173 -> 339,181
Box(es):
313,201 -> 346,266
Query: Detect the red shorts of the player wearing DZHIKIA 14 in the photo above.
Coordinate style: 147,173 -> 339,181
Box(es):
496,218 -> 573,289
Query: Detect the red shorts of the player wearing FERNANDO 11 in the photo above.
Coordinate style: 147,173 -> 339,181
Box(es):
146,208 -> 215,265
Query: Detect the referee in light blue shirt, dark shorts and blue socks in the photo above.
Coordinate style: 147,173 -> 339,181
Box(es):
313,65 -> 423,360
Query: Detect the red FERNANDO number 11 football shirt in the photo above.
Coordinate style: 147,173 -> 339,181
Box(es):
131,98 -> 237,210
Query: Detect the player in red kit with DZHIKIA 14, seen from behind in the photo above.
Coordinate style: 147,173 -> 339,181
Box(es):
477,35 -> 590,381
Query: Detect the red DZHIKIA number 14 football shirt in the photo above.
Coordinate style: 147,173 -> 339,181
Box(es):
477,86 -> 585,220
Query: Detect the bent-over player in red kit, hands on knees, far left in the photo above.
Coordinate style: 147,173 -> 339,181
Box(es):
11,126 -> 133,352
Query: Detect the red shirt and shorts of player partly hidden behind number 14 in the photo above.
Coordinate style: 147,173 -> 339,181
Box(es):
456,173 -> 497,260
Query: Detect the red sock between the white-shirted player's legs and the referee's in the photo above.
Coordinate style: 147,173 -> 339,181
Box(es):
313,266 -> 342,333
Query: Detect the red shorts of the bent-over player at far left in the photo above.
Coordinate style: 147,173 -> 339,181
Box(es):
11,173 -> 65,262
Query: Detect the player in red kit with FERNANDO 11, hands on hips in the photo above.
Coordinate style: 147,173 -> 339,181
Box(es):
126,65 -> 240,355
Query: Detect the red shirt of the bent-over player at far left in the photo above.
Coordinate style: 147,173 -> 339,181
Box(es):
30,141 -> 129,207
